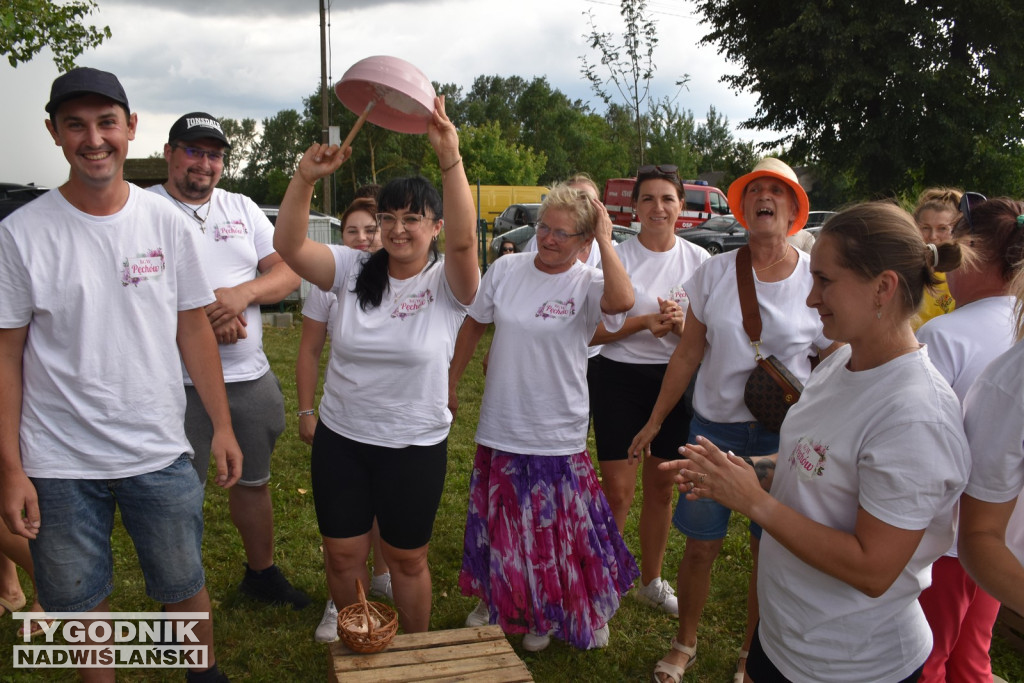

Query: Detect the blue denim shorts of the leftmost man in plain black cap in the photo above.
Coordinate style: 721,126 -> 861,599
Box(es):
29,454 -> 206,612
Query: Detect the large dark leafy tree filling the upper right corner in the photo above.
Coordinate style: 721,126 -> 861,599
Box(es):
698,0 -> 1024,199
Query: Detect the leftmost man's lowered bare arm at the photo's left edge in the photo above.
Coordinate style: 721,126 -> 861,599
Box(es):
0,326 -> 39,539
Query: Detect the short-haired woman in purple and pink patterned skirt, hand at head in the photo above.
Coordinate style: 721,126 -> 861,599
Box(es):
449,184 -> 639,652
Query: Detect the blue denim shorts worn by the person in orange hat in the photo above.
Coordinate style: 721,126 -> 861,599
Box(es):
672,412 -> 778,541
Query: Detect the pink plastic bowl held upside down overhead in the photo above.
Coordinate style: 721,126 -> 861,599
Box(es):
334,55 -> 436,133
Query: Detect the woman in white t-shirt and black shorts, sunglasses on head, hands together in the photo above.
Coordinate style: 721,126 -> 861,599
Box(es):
593,165 -> 711,616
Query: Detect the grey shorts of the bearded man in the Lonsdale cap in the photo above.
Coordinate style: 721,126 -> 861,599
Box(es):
185,371 -> 285,486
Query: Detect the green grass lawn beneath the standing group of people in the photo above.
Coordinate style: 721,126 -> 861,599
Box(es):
0,324 -> 1024,683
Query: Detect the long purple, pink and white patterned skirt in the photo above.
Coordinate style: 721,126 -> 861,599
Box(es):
459,445 -> 640,649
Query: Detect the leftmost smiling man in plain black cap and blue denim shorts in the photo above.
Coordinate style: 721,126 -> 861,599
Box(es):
0,69 -> 243,683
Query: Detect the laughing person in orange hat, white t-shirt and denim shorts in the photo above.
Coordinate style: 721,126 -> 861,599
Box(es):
629,158 -> 837,683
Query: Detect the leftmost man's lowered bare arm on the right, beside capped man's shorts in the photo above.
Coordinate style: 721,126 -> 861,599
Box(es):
177,308 -> 242,488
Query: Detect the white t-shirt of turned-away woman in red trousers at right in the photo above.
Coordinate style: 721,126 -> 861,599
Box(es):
918,296 -> 1017,402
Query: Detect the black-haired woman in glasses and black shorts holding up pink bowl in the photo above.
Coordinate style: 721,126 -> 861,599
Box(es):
273,97 -> 480,633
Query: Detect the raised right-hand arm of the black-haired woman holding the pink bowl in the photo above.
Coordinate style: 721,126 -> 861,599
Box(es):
427,96 -> 480,304
